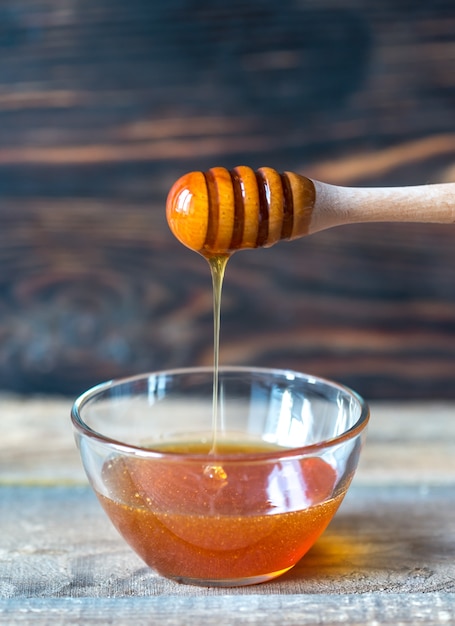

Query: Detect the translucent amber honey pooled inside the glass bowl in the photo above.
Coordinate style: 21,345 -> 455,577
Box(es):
98,443 -> 345,584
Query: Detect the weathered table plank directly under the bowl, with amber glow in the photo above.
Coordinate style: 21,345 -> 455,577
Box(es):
0,485 -> 455,598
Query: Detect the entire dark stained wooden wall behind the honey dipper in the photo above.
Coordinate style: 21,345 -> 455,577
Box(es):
0,0 -> 455,400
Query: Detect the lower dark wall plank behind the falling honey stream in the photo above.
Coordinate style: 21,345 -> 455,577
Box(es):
0,201 -> 455,400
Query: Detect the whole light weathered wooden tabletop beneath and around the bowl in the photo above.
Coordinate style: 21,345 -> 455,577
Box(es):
0,396 -> 455,626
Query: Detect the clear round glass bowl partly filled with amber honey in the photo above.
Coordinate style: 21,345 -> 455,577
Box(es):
71,367 -> 369,587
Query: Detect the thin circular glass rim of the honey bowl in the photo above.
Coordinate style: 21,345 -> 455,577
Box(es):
70,365 -> 370,462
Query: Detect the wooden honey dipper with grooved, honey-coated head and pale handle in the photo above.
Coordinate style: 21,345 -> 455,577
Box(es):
166,166 -> 455,257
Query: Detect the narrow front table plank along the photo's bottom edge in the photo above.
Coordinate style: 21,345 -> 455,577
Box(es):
0,592 -> 455,626
